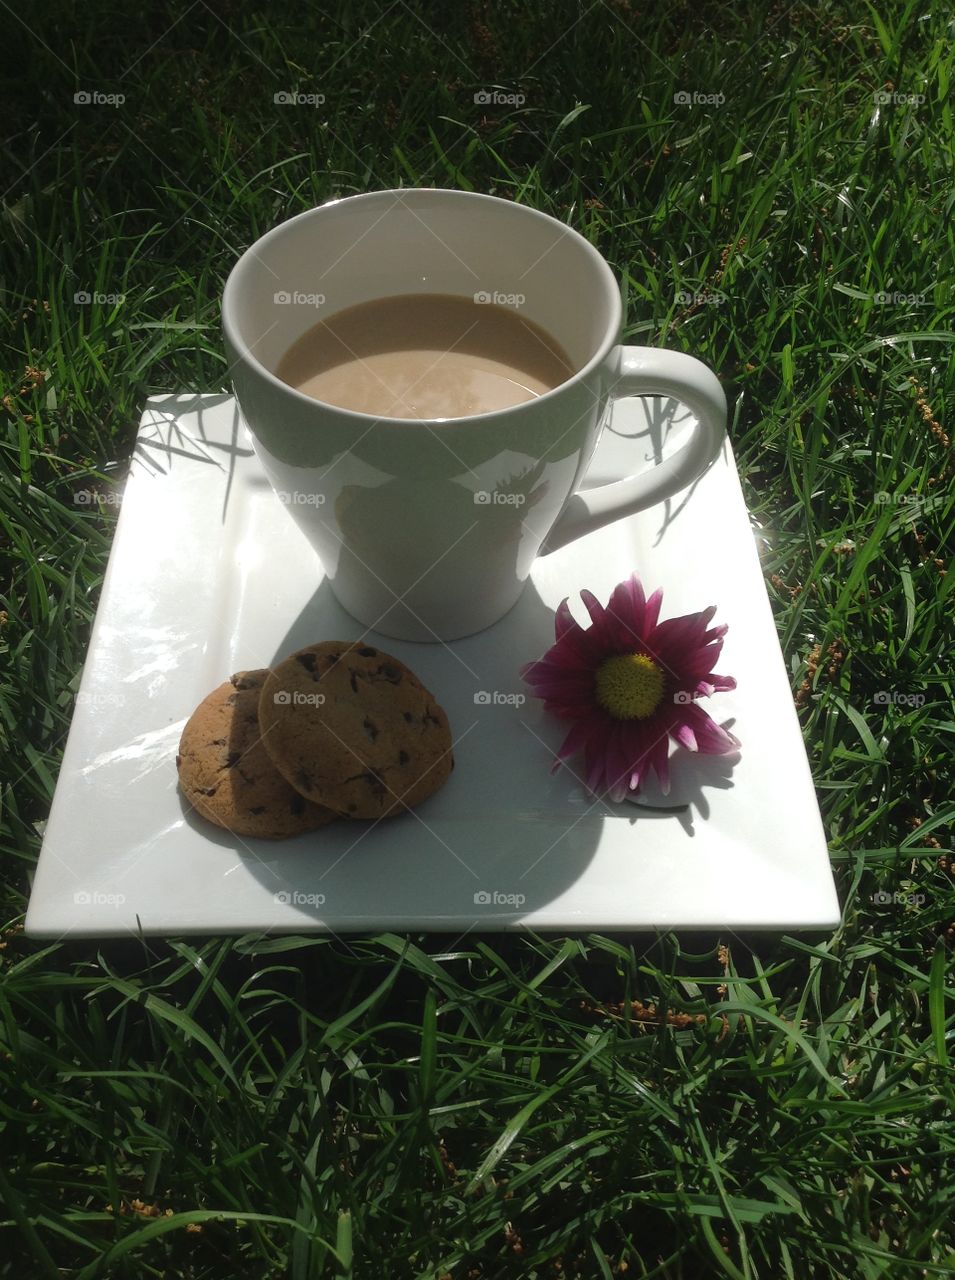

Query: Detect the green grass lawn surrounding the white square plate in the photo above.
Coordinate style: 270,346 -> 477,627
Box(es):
0,0 -> 955,1280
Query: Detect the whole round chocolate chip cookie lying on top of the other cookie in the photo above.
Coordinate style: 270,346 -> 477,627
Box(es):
259,640 -> 454,818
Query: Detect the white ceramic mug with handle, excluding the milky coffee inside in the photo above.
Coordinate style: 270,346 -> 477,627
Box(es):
223,189 -> 726,640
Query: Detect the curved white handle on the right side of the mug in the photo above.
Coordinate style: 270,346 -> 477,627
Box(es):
539,347 -> 726,556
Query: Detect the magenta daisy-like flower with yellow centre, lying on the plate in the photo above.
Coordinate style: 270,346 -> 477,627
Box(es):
521,573 -> 740,800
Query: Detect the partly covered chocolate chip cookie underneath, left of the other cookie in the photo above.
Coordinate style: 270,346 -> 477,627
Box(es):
175,671 -> 335,840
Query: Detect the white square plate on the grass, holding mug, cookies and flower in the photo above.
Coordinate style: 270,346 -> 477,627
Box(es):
26,394 -> 840,937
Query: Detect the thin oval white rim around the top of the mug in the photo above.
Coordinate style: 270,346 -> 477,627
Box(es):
221,187 -> 623,429
